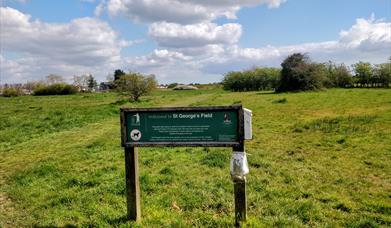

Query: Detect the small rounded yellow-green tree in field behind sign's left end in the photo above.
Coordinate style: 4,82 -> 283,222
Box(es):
115,72 -> 157,101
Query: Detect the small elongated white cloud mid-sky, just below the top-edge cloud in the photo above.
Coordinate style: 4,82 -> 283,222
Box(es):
149,22 -> 242,48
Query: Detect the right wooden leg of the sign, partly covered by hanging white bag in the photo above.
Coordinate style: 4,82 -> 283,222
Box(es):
233,143 -> 247,227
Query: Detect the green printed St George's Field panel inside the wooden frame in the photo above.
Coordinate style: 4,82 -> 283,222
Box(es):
125,110 -> 238,143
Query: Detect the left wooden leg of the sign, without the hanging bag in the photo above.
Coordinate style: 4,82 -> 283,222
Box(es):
125,147 -> 141,221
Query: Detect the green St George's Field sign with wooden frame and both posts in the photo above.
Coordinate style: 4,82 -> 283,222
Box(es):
121,105 -> 251,225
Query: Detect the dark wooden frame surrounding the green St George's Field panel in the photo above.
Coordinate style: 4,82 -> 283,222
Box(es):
120,105 -> 244,148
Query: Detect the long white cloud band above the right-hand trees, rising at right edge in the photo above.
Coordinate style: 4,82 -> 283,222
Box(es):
200,16 -> 391,73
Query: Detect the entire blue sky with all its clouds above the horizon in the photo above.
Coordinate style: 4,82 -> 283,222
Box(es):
0,0 -> 391,83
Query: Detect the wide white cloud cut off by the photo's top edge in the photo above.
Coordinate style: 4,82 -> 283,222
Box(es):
105,0 -> 285,24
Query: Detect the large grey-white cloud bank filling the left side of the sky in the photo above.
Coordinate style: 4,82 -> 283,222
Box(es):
0,7 -> 137,81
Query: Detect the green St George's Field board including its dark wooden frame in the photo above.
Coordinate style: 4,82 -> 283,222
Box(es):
121,105 -> 244,147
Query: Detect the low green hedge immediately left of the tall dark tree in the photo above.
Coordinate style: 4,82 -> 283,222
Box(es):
222,68 -> 280,91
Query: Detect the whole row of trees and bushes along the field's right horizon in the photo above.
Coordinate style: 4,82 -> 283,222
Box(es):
222,53 -> 391,92
